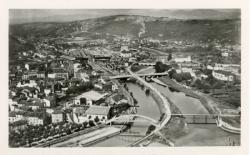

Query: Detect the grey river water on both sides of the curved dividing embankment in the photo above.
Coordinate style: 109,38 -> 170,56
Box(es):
93,80 -> 240,147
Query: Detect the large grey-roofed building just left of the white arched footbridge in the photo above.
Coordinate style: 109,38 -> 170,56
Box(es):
85,106 -> 110,121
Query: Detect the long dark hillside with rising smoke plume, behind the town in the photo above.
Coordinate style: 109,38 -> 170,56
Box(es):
10,15 -> 241,43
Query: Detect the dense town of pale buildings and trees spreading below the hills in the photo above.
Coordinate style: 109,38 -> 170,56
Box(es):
8,13 -> 241,147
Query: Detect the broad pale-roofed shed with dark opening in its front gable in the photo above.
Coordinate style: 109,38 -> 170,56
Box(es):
74,90 -> 107,106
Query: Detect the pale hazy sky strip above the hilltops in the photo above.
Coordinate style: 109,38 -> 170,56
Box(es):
9,9 -> 240,24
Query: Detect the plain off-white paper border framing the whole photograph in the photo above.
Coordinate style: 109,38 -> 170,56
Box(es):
0,0 -> 250,155
